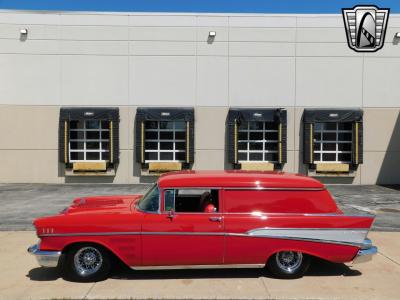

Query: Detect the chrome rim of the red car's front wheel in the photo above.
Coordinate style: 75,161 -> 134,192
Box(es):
74,247 -> 103,277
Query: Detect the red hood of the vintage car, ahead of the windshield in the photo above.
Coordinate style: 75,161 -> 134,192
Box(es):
62,195 -> 142,214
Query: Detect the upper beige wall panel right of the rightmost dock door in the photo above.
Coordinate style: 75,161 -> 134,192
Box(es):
364,108 -> 400,151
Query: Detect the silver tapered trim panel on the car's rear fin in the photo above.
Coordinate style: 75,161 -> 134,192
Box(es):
247,228 -> 369,245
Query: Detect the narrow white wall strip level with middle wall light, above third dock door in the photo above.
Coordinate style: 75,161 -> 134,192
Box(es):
229,27 -> 296,42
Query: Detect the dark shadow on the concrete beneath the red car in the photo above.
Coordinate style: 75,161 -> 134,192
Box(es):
26,259 -> 361,281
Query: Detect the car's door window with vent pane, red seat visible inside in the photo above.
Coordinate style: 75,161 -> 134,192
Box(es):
164,189 -> 219,213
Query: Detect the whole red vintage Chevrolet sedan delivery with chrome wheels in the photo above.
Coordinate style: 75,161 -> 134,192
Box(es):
28,171 -> 377,281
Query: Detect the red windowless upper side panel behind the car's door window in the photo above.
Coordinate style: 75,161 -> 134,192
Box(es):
224,190 -> 337,213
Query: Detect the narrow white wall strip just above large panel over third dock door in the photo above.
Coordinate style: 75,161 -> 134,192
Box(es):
229,42 -> 295,56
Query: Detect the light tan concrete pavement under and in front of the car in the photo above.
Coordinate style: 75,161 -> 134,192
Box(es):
0,231 -> 400,300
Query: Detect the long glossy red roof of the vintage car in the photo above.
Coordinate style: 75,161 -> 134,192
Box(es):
158,170 -> 324,189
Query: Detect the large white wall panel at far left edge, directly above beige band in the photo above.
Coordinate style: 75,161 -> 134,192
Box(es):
0,54 -> 60,105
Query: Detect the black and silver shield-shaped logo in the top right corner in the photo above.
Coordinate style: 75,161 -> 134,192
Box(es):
342,5 -> 390,52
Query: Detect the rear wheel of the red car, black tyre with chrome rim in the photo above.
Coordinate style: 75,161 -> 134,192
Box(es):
267,251 -> 311,279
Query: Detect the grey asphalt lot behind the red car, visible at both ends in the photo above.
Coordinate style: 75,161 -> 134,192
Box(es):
0,184 -> 400,231
